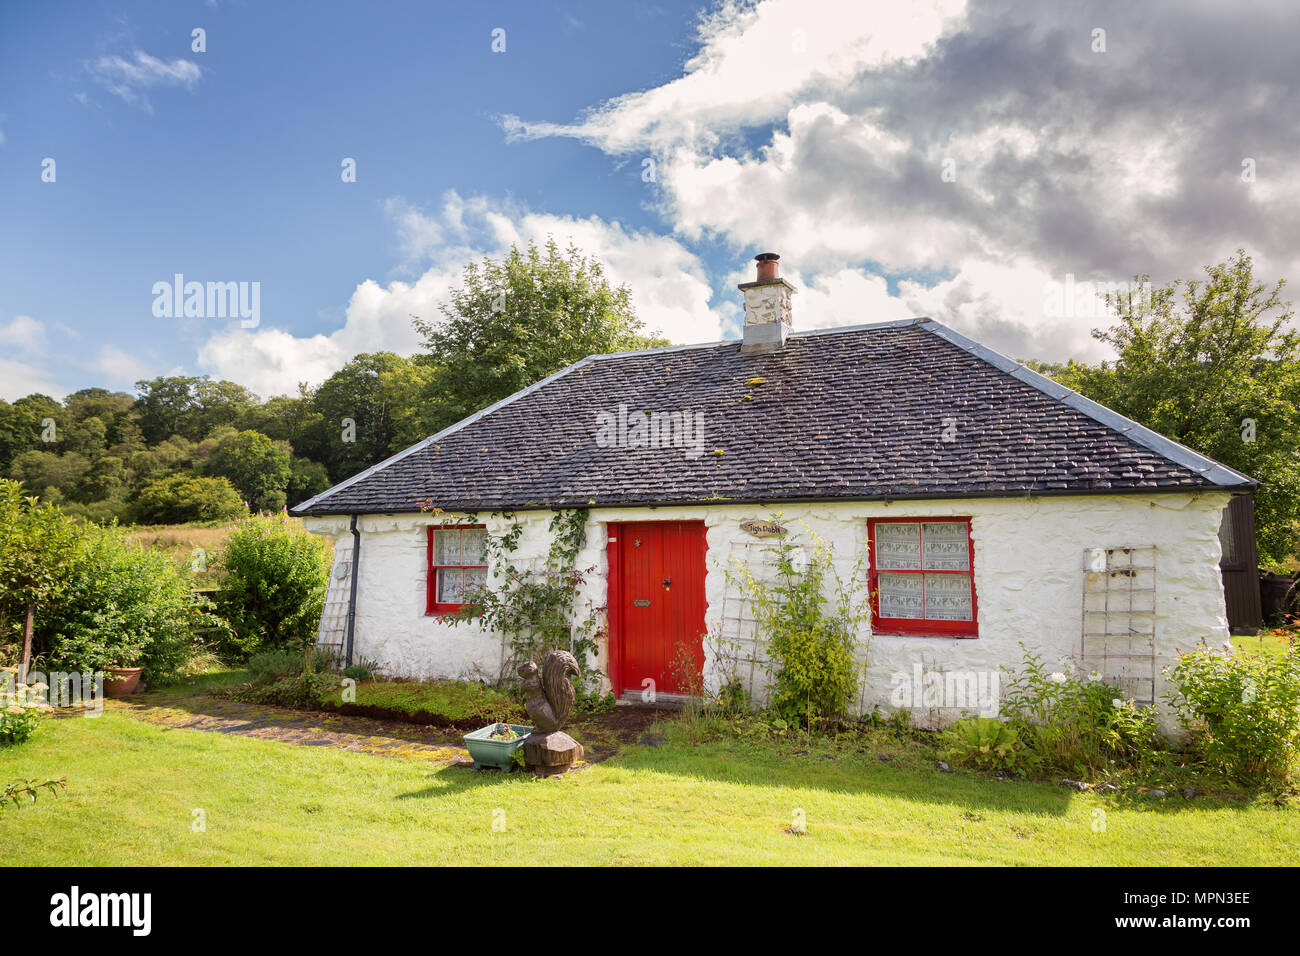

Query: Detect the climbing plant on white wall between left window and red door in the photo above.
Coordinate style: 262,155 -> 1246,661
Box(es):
451,509 -> 605,706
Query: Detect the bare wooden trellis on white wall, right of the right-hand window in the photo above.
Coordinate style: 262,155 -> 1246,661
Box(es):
1082,546 -> 1156,704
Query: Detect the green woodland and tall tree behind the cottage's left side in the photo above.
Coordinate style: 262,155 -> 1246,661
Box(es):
0,241 -> 667,524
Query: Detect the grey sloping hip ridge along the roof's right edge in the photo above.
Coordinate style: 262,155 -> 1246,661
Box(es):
917,316 -> 1260,488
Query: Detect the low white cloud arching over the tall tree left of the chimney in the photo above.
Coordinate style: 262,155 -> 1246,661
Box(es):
198,191 -> 738,395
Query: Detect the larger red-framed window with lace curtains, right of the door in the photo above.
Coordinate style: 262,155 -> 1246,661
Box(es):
870,518 -> 979,637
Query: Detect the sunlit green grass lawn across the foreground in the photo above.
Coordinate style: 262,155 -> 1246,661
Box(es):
0,711 -> 1300,866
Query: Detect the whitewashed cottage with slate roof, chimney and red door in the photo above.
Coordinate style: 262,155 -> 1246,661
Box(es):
294,254 -> 1257,724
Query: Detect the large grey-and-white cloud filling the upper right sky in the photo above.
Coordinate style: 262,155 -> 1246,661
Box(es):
502,0 -> 1300,359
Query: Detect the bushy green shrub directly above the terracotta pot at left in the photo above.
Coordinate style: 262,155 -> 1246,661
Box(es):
36,525 -> 212,682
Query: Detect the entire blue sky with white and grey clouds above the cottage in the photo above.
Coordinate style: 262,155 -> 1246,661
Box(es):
0,0 -> 1300,399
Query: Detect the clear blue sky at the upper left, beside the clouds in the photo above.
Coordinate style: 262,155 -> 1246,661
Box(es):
0,3 -> 717,397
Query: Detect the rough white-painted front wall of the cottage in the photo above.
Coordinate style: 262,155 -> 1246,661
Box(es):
306,493 -> 1229,726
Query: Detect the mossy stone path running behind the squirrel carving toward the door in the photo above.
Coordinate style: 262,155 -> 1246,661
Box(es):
105,691 -> 671,769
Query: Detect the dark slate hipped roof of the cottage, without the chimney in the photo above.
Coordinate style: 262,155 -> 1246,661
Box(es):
293,319 -> 1257,515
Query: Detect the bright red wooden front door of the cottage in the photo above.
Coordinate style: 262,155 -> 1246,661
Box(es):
610,522 -> 707,693
